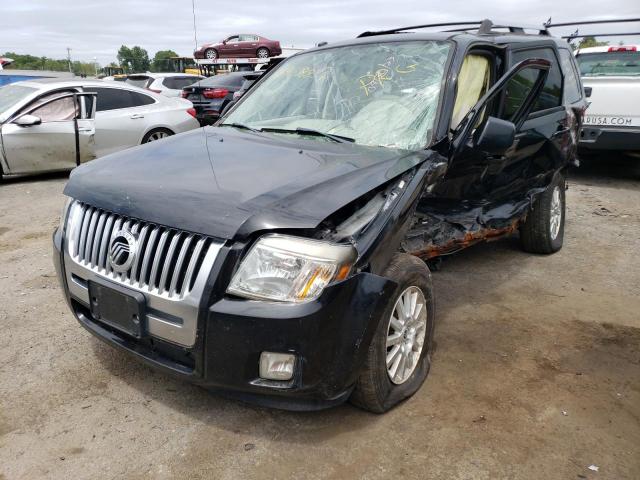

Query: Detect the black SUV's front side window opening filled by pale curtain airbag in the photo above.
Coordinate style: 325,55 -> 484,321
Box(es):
451,53 -> 491,128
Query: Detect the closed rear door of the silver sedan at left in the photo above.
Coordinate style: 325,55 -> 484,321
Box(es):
84,87 -> 156,157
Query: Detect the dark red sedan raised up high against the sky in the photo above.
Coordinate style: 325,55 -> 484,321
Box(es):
193,33 -> 282,60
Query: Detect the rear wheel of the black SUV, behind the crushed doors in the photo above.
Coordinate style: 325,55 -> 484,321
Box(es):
520,174 -> 566,254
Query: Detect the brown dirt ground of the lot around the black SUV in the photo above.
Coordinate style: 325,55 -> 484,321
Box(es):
0,158 -> 640,480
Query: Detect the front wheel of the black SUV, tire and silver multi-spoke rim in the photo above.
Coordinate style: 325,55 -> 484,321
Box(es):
350,254 -> 435,413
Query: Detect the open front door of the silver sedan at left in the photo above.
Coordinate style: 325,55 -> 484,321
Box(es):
2,91 -> 95,174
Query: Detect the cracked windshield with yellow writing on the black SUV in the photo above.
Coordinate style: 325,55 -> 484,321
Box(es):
223,41 -> 450,149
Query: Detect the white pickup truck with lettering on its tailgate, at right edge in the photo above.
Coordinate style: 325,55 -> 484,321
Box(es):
575,45 -> 640,156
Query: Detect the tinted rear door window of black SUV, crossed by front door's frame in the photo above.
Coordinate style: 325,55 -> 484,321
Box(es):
502,48 -> 562,120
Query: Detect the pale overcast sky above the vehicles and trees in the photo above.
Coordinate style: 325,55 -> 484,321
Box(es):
0,0 -> 640,65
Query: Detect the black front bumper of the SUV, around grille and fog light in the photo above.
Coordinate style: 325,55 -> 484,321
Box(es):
54,231 -> 396,410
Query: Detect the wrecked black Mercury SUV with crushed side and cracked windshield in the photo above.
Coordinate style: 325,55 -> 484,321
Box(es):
54,21 -> 586,412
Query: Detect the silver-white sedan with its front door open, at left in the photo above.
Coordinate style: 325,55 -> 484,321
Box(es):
0,80 -> 199,176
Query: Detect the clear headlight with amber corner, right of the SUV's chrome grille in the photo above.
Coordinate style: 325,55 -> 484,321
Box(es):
227,235 -> 357,303
